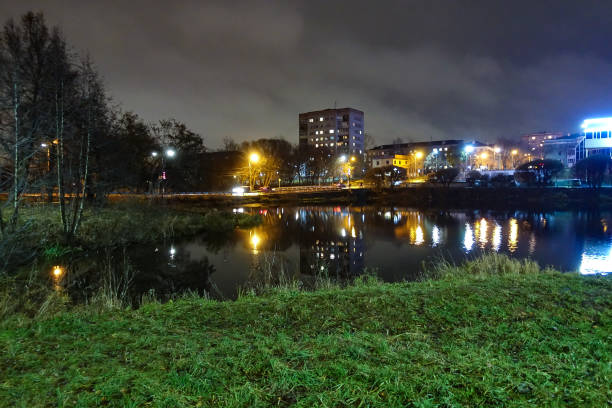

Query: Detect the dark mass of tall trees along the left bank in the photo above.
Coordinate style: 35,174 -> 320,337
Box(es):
0,12 -> 206,238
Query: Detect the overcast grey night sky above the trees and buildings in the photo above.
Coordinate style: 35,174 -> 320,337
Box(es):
0,0 -> 612,148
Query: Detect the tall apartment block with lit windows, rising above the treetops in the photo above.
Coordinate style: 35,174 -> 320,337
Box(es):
299,108 -> 365,156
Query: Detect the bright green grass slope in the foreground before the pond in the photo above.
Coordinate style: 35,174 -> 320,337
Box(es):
0,264 -> 612,407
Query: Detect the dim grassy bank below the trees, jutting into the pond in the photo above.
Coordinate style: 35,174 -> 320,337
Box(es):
0,203 -> 262,272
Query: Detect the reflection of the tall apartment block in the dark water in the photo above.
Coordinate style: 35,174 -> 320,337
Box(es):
300,208 -> 364,277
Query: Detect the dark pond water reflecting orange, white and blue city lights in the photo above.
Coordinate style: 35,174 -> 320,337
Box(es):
59,206 -> 612,298
